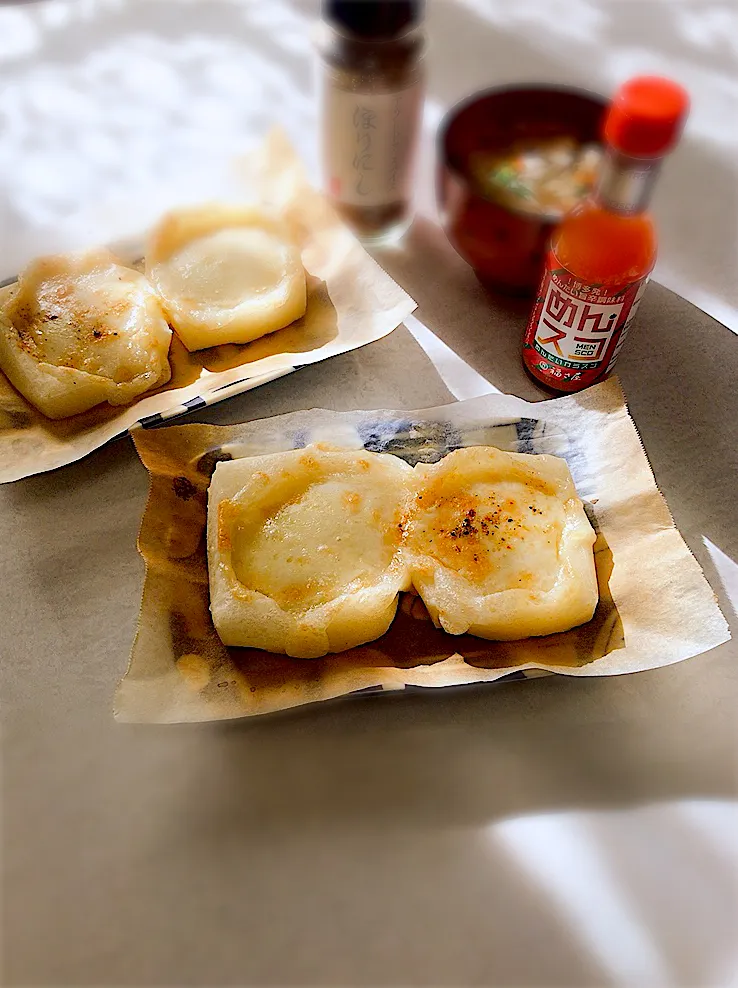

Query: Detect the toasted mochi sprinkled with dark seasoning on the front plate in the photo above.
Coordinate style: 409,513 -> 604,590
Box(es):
405,446 -> 598,640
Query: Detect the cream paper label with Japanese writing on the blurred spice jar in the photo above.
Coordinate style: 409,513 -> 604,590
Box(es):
323,82 -> 422,206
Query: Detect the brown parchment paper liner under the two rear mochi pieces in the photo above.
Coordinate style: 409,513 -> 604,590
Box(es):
0,132 -> 416,483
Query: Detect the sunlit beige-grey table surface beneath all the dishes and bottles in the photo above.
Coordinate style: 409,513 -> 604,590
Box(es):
0,0 -> 738,988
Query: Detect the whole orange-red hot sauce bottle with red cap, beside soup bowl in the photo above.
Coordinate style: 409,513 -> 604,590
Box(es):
523,76 -> 689,392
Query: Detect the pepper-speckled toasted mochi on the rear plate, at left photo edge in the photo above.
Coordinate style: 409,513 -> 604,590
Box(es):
0,249 -> 172,419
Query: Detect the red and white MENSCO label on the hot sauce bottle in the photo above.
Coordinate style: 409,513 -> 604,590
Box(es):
523,251 -> 648,391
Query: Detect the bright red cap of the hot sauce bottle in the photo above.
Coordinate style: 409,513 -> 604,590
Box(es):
605,75 -> 689,158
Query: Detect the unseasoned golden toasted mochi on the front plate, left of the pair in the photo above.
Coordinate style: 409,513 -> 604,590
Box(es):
208,445 -> 414,658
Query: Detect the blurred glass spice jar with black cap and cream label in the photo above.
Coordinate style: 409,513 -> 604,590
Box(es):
318,0 -> 425,245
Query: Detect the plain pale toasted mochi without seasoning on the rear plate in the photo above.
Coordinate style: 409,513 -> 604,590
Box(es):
146,203 -> 307,350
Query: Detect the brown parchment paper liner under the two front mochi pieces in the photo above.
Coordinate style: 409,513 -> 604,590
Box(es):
115,380 -> 730,722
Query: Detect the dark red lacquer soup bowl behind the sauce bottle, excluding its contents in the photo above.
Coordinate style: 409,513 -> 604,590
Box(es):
436,85 -> 607,295
